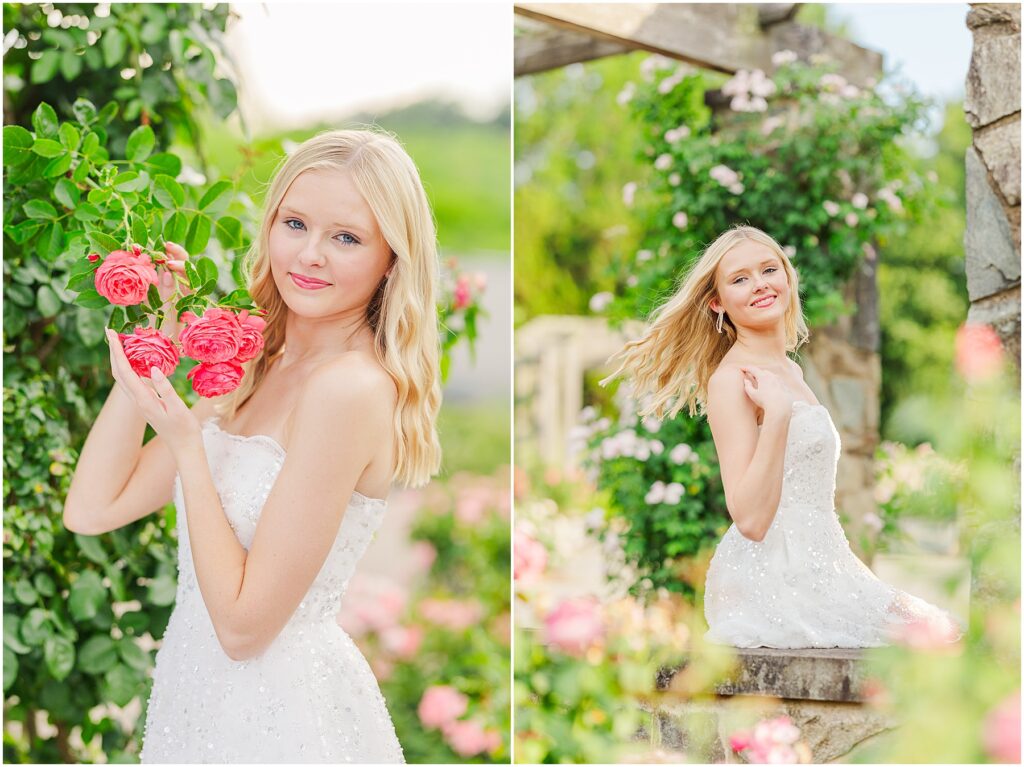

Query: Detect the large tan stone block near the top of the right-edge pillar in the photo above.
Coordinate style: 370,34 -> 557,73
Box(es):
964,34 -> 1021,128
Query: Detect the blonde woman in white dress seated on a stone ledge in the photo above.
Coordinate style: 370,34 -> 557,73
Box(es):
615,226 -> 961,648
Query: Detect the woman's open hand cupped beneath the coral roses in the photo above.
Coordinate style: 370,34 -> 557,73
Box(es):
106,329 -> 203,460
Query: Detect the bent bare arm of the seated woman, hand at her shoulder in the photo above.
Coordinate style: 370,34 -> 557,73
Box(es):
708,367 -> 793,541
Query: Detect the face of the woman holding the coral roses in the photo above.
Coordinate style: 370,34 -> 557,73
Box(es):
269,170 -> 392,317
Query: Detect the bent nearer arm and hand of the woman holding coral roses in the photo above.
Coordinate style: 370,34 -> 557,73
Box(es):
117,344 -> 397,661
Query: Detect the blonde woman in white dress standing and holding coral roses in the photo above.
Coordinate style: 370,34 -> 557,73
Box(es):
65,131 -> 440,763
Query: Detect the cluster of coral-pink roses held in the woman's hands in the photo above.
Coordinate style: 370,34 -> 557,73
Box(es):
87,245 -> 266,397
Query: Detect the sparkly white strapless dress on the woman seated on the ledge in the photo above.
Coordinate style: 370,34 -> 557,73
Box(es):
705,400 -> 963,648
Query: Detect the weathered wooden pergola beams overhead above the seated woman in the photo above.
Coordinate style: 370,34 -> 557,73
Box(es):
515,3 -> 882,85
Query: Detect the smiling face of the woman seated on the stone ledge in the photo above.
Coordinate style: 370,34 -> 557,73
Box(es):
711,240 -> 791,328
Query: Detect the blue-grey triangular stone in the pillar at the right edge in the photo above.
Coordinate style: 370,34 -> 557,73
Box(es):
964,146 -> 1021,301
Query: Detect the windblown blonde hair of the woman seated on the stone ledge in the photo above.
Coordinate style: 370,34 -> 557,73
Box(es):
601,224 -> 810,418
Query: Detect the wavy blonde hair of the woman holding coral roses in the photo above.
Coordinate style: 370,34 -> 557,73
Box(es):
223,125 -> 441,486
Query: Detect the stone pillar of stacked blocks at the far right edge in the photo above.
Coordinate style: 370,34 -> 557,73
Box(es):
964,3 -> 1021,377
